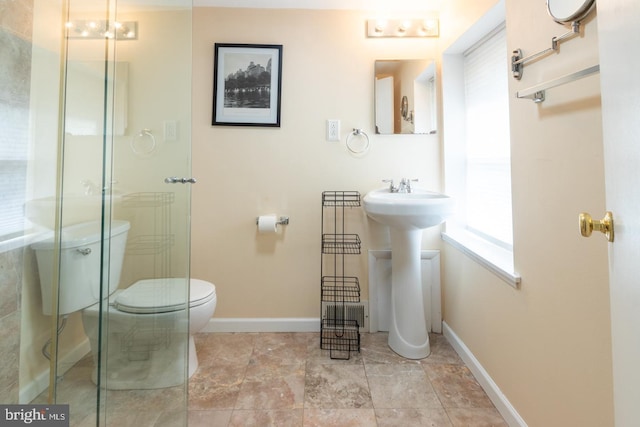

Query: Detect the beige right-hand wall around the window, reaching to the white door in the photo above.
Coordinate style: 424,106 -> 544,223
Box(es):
442,0 -> 613,427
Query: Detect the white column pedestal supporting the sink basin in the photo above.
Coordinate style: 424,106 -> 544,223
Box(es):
389,227 -> 431,359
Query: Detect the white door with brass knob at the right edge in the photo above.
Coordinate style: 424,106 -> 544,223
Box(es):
597,0 -> 640,427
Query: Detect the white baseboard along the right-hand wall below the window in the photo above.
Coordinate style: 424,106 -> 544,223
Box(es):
442,322 -> 527,427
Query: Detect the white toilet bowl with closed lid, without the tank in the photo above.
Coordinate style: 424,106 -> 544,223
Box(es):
82,278 -> 217,390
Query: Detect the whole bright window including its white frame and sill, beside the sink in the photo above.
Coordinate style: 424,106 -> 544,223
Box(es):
442,2 -> 520,286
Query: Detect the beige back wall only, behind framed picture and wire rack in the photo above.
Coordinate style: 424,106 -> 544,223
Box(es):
191,8 -> 440,318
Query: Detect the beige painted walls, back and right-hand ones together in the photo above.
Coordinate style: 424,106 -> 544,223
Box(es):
192,0 -> 613,426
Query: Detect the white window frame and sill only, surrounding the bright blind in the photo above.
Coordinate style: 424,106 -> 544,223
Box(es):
442,1 -> 520,287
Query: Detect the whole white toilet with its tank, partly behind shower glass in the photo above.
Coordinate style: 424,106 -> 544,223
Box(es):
32,221 -> 217,390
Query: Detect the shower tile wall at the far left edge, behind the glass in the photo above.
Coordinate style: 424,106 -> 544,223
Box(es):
0,0 -> 33,403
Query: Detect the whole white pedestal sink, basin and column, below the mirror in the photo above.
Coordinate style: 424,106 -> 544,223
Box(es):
363,188 -> 454,359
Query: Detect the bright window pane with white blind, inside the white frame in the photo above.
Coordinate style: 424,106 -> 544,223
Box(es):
464,26 -> 513,248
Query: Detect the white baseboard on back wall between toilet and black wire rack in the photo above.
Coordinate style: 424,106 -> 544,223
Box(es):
201,317 -> 320,332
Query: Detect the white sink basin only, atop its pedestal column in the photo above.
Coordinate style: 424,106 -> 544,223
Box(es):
363,188 -> 454,229
